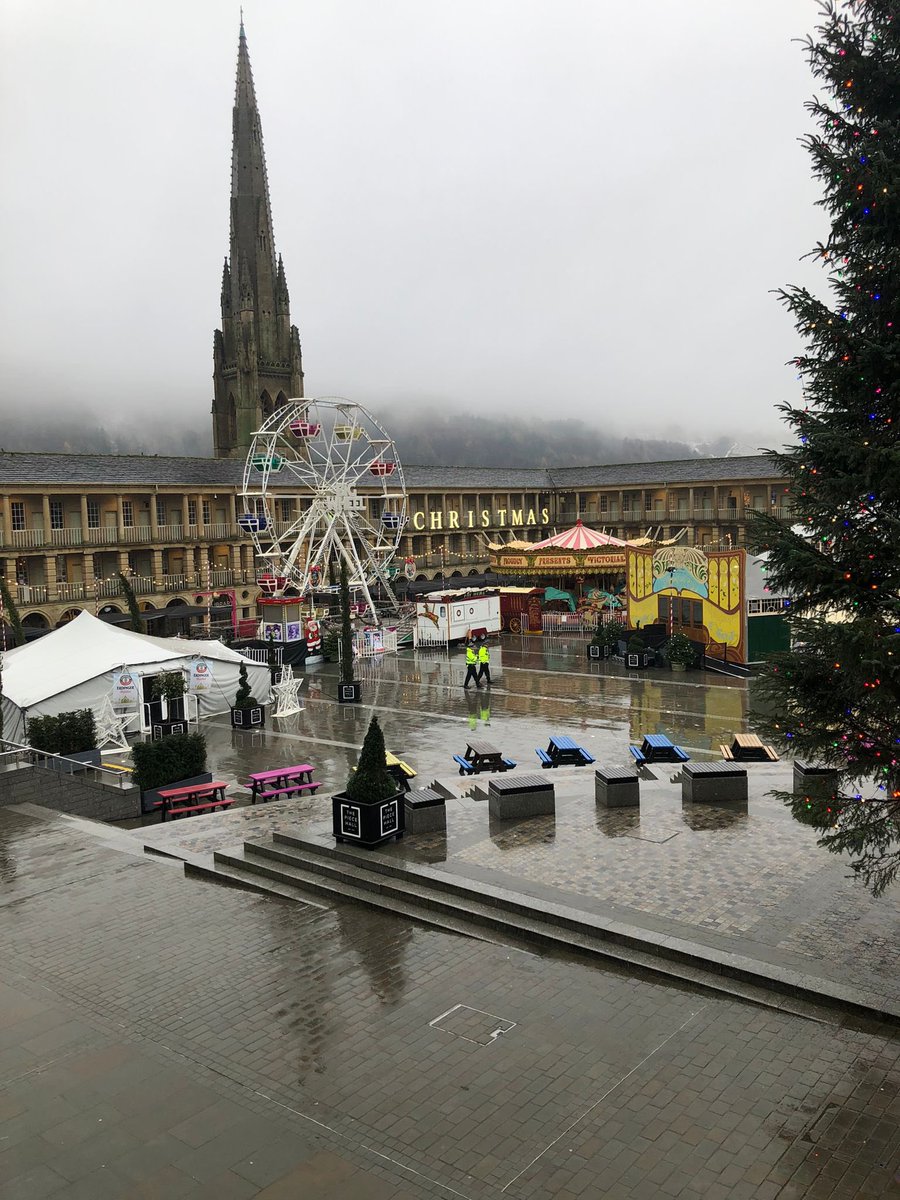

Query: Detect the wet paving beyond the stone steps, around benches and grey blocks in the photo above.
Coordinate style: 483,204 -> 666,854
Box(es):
140,638 -> 900,1002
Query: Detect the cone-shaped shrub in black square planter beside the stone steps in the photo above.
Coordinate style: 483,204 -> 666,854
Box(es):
331,716 -> 406,846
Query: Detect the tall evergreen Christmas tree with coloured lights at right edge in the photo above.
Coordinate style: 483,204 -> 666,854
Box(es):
752,0 -> 900,894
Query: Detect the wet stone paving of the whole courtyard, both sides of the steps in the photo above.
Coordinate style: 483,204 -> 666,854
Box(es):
0,641 -> 900,1200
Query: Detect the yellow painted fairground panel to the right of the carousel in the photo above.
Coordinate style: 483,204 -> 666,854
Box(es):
626,546 -> 746,662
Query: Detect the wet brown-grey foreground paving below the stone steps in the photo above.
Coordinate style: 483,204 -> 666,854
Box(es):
0,802 -> 900,1200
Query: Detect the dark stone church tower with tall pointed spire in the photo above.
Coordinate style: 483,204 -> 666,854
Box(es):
212,22 -> 304,458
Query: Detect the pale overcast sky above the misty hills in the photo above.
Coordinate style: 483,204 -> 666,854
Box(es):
0,0 -> 826,445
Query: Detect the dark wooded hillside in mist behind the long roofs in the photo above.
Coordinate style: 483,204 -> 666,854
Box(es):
0,409 -> 756,467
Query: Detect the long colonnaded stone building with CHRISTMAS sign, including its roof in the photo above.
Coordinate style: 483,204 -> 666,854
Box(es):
0,452 -> 790,632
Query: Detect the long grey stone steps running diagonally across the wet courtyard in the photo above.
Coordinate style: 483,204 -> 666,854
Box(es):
191,834 -> 900,1022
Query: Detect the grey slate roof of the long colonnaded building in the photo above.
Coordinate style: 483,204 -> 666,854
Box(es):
0,451 -> 784,492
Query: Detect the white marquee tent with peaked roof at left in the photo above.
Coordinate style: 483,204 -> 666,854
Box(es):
2,612 -> 270,742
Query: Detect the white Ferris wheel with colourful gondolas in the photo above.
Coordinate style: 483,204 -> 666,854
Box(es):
240,396 -> 407,616
